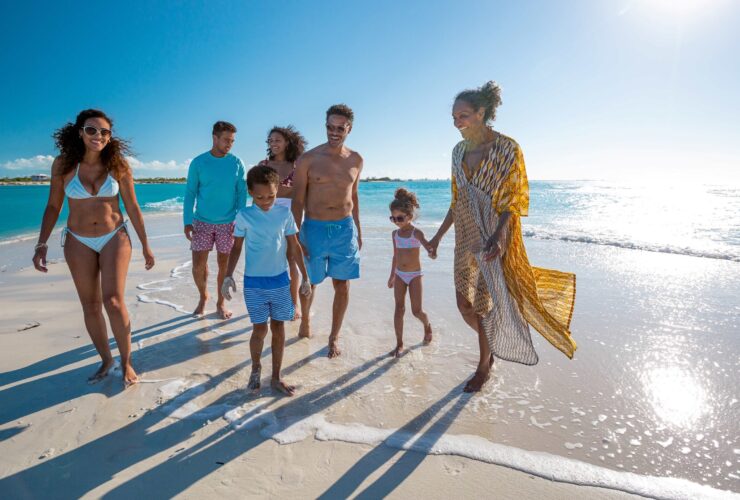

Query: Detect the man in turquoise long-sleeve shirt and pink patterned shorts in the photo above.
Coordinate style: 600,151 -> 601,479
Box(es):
183,121 -> 247,319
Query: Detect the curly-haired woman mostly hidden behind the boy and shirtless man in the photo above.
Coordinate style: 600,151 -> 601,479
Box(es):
260,125 -> 307,320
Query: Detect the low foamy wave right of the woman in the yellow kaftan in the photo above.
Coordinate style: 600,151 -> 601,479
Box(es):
522,229 -> 740,262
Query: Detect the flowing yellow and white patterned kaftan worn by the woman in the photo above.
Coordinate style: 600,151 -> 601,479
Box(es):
450,132 -> 576,365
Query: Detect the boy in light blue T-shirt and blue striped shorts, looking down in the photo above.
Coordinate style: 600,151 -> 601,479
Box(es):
222,165 -> 311,396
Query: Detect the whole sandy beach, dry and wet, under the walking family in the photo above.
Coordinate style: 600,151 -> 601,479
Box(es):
0,215 -> 740,499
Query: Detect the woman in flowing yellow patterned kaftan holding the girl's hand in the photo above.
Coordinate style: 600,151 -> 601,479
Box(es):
430,82 -> 576,392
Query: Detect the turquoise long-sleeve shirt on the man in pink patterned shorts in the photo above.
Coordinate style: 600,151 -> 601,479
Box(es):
183,151 -> 247,226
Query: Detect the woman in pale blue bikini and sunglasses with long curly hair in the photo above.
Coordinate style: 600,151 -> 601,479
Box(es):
33,109 -> 154,387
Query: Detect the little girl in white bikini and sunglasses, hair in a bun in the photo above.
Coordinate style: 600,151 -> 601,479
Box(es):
388,188 -> 432,358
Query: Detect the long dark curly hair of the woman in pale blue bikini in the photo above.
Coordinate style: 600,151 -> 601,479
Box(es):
52,109 -> 132,179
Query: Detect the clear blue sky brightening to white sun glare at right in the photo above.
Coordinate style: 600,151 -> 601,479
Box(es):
0,0 -> 740,183
